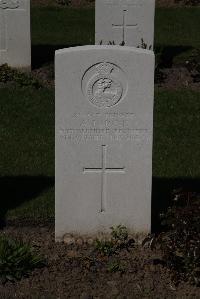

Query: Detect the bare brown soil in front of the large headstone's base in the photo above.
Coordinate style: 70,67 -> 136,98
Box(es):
0,225 -> 200,299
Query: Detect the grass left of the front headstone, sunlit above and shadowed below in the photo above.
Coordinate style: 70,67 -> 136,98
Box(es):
0,88 -> 54,219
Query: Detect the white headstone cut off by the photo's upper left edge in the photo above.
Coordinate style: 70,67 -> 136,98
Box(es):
0,0 -> 31,68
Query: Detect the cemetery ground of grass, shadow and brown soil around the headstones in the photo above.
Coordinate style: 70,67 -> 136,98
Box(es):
0,2 -> 200,298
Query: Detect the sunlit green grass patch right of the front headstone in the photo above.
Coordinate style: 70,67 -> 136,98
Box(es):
153,90 -> 200,178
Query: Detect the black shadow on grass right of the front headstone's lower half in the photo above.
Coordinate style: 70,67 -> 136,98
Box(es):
151,178 -> 200,233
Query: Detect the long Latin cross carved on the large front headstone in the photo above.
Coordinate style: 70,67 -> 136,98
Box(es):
83,145 -> 125,212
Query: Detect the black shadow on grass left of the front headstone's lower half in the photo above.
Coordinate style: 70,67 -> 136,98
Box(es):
0,176 -> 54,227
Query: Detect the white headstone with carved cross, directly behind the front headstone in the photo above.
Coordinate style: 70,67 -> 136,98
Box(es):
95,0 -> 155,49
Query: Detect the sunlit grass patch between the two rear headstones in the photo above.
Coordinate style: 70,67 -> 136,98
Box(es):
31,7 -> 95,46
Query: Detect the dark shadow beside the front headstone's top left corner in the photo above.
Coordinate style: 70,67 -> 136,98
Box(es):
31,45 -> 80,69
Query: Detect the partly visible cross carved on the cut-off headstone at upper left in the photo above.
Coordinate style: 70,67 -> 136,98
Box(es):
0,0 -> 19,50
